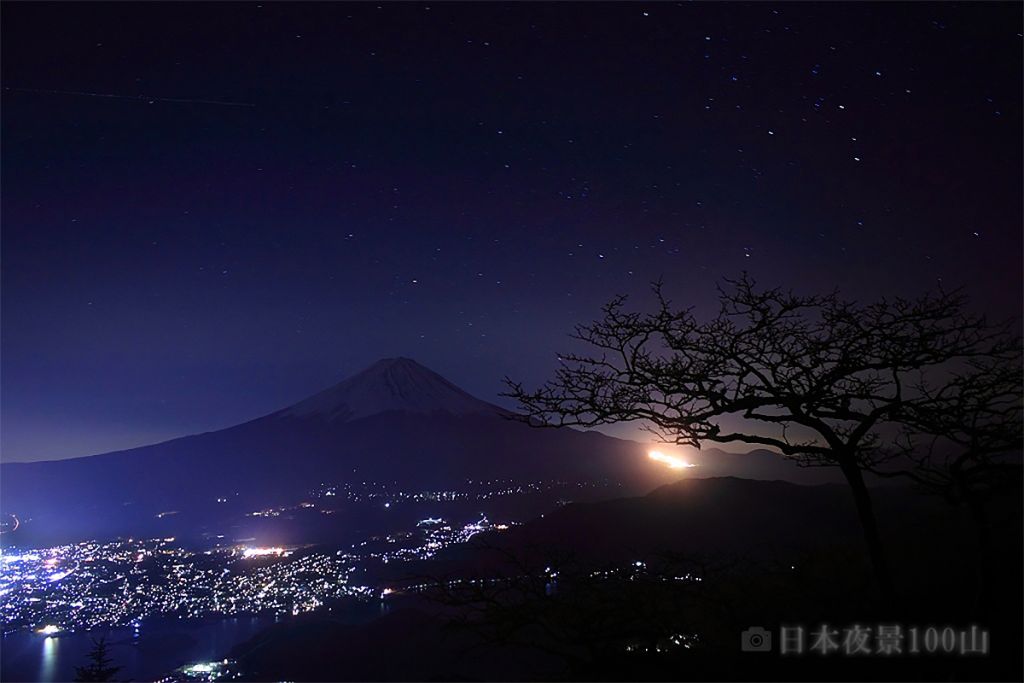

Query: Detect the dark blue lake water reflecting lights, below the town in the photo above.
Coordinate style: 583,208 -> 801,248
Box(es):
0,616 -> 273,683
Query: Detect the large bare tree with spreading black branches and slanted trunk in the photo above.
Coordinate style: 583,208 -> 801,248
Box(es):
506,274 -> 1020,601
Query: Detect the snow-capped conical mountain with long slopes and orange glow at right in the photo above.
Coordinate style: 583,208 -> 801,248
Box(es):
0,358 -> 839,543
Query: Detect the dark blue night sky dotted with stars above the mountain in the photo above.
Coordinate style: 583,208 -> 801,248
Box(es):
0,2 -> 1022,461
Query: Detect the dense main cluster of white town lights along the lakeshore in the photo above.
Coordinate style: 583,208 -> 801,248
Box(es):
0,515 -> 514,637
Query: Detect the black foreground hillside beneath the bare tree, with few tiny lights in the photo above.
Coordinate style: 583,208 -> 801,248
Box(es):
233,478 -> 1022,680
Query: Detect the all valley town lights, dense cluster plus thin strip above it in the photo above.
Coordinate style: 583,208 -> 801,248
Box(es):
0,479 -> 613,634
